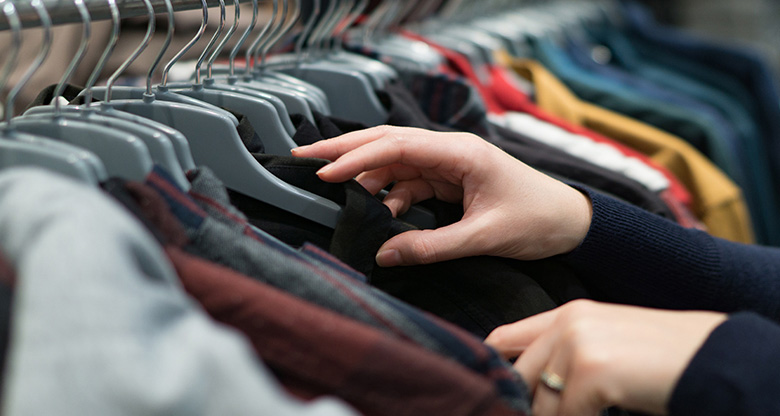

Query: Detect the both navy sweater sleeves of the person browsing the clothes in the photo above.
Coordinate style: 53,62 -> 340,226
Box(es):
563,188 -> 780,416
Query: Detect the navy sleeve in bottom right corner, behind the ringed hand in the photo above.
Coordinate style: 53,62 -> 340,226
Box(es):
669,313 -> 780,416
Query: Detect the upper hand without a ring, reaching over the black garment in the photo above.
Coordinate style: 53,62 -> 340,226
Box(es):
293,126 -> 591,267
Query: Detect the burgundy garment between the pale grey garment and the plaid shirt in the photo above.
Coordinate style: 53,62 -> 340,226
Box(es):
167,248 -> 517,416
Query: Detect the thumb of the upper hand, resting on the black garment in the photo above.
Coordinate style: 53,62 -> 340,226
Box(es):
376,221 -> 485,267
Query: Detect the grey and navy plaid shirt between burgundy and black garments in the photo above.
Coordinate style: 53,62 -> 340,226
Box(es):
142,168 -> 530,412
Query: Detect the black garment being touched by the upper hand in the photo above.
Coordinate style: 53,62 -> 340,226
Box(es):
230,117 -> 581,338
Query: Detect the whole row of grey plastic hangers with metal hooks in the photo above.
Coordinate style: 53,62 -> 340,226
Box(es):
0,0 -> 608,228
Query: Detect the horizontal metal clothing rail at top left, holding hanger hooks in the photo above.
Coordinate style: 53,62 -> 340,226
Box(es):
0,0 -> 249,30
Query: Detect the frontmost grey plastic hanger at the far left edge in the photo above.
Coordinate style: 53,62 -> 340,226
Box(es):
0,1 -> 108,185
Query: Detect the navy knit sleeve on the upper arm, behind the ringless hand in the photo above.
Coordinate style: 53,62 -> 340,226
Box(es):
562,187 -> 780,321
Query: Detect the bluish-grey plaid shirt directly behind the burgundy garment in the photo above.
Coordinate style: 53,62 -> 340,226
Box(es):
140,169 -> 528,410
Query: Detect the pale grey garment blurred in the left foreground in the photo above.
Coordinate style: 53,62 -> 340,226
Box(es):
0,169 -> 354,416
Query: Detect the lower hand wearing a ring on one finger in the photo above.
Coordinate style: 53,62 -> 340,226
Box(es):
485,301 -> 726,416
